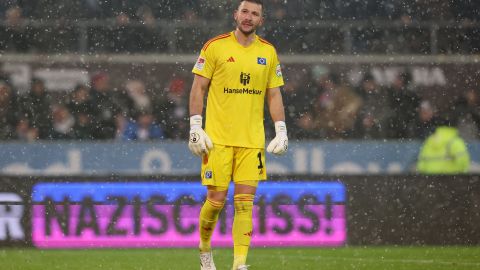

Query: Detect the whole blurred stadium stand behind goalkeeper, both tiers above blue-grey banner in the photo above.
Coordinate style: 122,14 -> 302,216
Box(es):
0,0 -> 480,140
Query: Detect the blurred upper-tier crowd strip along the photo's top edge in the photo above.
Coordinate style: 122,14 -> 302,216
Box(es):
0,0 -> 480,21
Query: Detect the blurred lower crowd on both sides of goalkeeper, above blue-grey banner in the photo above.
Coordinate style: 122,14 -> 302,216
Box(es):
0,65 -> 480,141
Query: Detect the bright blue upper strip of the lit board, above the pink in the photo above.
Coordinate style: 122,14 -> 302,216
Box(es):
32,181 -> 346,203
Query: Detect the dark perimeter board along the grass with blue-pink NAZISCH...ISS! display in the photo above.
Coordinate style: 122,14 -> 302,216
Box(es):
0,175 -> 480,248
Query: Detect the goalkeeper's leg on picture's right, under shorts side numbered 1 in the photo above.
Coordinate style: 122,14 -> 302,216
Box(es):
232,148 -> 266,270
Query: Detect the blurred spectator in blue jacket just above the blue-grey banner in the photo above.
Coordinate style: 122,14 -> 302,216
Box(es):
123,111 -> 164,141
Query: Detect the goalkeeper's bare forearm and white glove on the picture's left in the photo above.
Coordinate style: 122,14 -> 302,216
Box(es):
188,74 -> 213,157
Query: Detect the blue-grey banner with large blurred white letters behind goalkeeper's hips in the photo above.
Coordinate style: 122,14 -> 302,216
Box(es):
0,141 -> 480,176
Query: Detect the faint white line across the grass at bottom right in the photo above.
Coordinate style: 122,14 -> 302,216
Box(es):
254,254 -> 480,266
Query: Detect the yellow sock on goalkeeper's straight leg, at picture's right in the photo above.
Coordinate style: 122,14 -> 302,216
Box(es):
232,194 -> 255,269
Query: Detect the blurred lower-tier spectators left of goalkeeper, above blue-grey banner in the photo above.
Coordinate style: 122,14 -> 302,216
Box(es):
0,72 -> 188,141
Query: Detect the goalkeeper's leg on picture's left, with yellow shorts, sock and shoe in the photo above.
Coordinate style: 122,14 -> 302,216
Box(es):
198,145 -> 233,270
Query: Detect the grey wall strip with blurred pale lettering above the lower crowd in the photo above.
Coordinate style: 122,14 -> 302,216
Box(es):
0,57 -> 479,107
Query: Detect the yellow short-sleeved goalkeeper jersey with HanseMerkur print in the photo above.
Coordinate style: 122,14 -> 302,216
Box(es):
192,32 -> 283,148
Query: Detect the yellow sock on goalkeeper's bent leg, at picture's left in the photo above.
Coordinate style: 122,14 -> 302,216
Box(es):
199,199 -> 225,252
